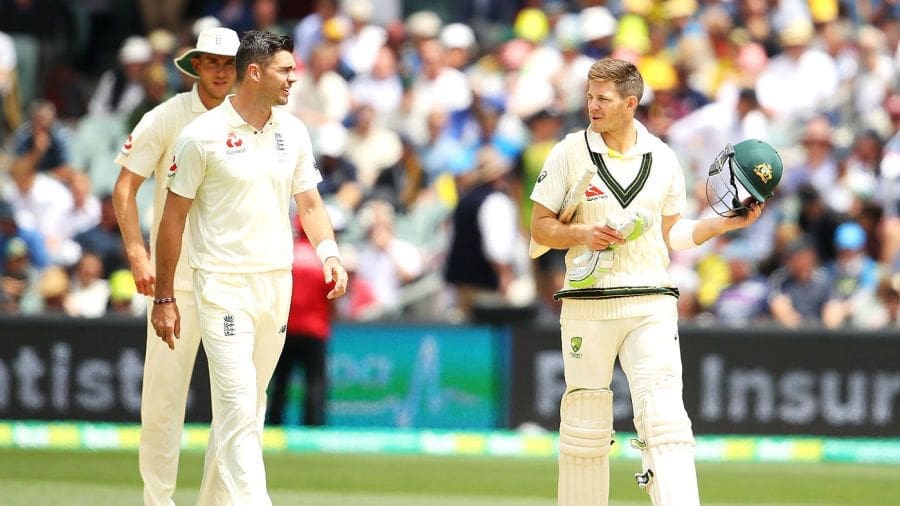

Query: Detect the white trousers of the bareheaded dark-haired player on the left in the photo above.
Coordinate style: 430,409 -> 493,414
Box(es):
194,270 -> 292,506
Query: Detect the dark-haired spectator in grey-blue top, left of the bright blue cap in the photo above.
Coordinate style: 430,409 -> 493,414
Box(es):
768,236 -> 831,328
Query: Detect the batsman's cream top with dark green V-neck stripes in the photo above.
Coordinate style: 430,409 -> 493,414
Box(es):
531,121 -> 686,318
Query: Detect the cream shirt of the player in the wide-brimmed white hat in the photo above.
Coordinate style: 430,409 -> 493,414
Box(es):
116,84 -> 206,291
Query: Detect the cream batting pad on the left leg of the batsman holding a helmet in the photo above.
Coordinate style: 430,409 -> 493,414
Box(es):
557,389 -> 613,506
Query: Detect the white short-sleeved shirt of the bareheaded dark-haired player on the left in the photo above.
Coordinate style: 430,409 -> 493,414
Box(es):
169,96 -> 322,273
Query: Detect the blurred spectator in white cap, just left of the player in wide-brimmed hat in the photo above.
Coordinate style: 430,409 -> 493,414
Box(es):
88,35 -> 153,120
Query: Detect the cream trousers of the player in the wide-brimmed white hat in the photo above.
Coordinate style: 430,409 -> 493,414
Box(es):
138,290 -> 200,506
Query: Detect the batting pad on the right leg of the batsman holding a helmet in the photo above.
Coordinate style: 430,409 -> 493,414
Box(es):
634,378 -> 700,506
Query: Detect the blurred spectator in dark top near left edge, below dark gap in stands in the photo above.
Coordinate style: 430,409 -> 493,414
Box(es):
12,100 -> 75,181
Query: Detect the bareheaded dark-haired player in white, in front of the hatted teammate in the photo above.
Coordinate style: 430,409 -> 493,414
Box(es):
151,30 -> 347,506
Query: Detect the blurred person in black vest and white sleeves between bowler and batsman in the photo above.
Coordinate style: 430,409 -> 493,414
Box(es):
445,147 -> 519,319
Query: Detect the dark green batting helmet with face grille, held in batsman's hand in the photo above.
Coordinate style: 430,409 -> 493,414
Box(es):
706,139 -> 784,217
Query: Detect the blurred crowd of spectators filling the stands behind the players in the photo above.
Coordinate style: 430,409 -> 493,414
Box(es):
0,0 -> 900,329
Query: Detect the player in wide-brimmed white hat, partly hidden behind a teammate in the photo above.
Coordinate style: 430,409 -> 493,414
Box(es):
113,27 -> 240,506
